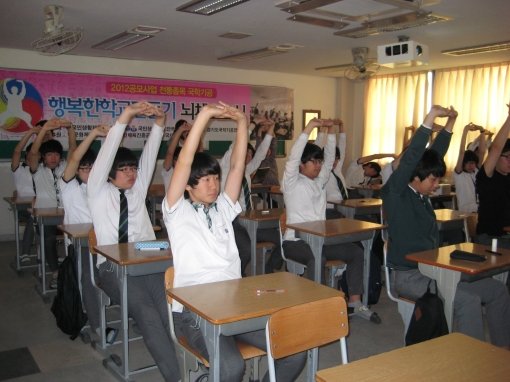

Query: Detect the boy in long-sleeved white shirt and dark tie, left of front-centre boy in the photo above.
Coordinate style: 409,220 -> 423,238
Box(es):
87,102 -> 180,381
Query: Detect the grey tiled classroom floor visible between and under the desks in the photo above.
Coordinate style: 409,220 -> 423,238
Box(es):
0,242 -> 403,382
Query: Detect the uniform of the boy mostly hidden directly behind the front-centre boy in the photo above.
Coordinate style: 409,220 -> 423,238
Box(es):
220,134 -> 282,274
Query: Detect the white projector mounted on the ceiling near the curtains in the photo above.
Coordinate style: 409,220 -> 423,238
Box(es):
377,41 -> 429,68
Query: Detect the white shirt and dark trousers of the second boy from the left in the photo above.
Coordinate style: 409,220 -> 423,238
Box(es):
32,160 -> 67,272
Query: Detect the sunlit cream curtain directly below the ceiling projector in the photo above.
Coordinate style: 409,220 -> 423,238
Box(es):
363,72 -> 429,156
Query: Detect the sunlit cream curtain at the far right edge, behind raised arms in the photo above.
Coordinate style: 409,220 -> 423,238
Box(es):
432,62 -> 510,170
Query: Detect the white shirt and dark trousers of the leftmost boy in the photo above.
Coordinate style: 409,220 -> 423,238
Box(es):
12,163 -> 35,255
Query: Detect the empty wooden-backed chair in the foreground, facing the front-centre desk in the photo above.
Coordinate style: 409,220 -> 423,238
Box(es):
266,295 -> 349,382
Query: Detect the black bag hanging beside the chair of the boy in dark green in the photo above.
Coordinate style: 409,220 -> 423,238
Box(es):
406,280 -> 449,346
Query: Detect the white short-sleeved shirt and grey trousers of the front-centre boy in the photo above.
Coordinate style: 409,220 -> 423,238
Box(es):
162,194 -> 306,382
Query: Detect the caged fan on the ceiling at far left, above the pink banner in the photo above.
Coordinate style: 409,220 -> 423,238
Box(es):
32,5 -> 83,56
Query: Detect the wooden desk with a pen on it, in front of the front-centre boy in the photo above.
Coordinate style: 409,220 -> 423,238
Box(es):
167,272 -> 343,382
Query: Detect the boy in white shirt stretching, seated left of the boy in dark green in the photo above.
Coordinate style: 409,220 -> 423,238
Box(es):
282,119 -> 381,324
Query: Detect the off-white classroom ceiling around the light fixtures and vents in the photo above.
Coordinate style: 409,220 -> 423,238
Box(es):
0,0 -> 510,76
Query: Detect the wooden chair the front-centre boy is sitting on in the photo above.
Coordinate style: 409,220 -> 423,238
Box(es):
165,267 -> 266,382
